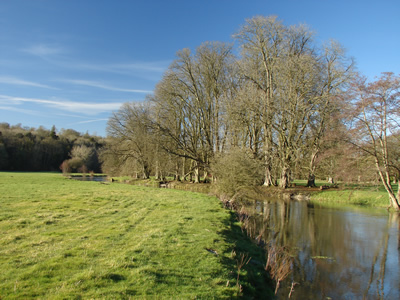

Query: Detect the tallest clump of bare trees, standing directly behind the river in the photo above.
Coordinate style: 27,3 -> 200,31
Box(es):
235,17 -> 352,188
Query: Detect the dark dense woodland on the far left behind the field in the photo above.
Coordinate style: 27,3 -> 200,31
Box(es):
0,123 -> 105,172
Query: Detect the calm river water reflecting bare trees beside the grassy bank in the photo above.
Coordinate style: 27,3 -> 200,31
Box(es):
242,199 -> 400,299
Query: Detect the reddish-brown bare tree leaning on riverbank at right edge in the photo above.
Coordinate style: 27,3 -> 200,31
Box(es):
349,73 -> 400,210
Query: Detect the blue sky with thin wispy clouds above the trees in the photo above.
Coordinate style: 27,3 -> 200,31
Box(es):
0,0 -> 400,136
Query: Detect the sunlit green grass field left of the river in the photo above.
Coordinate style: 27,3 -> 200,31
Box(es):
0,172 -> 270,299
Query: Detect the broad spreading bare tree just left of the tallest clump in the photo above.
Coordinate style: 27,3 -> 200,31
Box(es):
153,42 -> 234,181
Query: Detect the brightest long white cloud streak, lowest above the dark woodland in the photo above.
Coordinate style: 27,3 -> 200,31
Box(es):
0,95 -> 123,115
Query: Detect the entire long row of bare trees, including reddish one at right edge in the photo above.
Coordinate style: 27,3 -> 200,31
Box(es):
101,17 -> 400,207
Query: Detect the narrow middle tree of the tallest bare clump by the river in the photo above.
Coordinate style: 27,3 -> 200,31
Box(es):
272,26 -> 320,188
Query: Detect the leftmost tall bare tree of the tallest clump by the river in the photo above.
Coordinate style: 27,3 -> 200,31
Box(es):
234,16 -> 286,186
